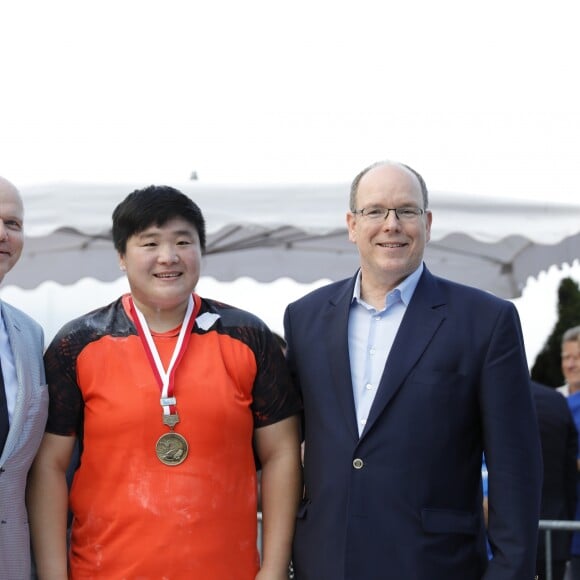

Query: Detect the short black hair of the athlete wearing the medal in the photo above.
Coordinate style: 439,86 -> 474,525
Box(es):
113,185 -> 205,255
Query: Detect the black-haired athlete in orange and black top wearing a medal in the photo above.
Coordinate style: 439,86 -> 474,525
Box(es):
28,186 -> 300,580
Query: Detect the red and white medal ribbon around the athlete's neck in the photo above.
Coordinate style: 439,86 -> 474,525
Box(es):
130,294 -> 201,422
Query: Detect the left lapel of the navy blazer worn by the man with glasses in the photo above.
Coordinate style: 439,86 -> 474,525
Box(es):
322,277 -> 358,440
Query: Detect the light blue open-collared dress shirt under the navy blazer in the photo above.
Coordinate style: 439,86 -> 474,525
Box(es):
348,263 -> 423,436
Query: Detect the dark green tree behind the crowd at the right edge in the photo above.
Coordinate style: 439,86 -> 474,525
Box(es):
531,278 -> 580,387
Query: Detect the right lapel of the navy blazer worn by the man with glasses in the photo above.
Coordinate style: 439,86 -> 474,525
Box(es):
361,268 -> 445,438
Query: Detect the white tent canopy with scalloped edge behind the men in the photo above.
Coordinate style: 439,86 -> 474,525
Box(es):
12,181 -> 580,298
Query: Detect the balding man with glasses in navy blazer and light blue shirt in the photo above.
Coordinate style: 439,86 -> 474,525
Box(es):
284,162 -> 542,580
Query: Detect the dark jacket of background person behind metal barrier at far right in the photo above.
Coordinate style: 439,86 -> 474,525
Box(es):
532,383 -> 578,560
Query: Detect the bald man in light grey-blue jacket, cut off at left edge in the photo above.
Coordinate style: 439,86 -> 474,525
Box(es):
0,177 -> 48,580
